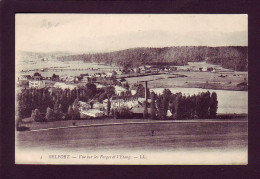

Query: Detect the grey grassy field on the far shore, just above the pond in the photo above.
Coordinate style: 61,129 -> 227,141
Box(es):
126,71 -> 248,90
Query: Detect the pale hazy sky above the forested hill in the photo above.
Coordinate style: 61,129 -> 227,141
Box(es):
15,13 -> 248,53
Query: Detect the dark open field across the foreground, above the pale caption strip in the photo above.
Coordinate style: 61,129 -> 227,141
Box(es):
16,120 -> 247,151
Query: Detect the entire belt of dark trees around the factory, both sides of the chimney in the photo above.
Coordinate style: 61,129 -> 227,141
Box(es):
17,83 -> 218,121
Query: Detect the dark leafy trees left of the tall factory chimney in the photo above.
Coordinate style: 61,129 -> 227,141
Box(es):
17,83 -> 145,118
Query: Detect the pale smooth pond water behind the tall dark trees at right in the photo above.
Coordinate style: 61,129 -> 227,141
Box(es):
151,88 -> 248,114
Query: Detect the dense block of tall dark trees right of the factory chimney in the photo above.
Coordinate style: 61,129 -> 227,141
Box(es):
147,89 -> 218,119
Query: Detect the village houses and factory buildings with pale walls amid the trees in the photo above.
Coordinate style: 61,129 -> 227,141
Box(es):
17,60 -> 228,119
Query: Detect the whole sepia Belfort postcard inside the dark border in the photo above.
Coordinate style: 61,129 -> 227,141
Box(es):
15,13 -> 248,165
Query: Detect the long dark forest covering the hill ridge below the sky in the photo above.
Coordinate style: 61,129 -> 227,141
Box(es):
58,46 -> 248,71
